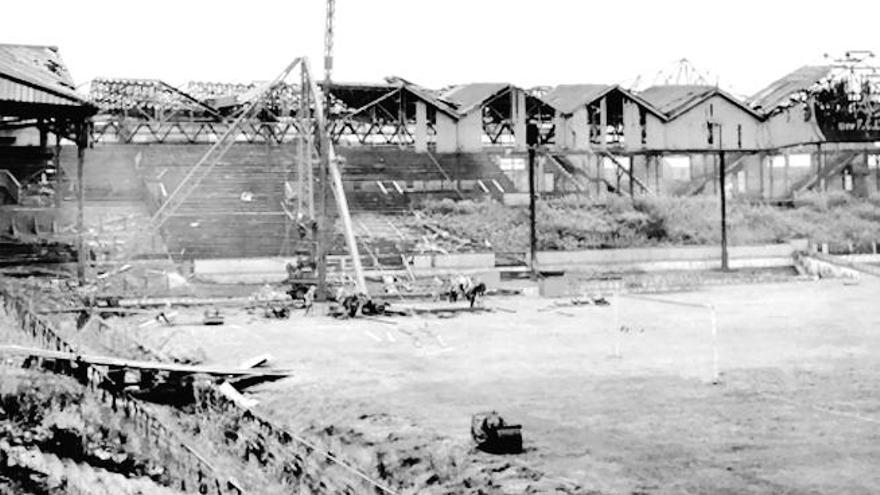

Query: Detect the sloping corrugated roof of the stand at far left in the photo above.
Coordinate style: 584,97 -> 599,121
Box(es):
0,44 -> 85,106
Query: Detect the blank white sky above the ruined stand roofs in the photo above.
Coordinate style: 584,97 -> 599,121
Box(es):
6,0 -> 880,94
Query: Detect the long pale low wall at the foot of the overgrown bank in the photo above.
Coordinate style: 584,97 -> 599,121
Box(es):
538,241 -> 807,271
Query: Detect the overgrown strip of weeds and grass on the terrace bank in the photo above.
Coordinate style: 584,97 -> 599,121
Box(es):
408,193 -> 880,252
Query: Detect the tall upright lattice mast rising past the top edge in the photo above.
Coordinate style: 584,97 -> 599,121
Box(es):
315,0 -> 336,301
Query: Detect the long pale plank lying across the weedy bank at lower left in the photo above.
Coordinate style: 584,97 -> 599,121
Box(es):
0,345 -> 292,377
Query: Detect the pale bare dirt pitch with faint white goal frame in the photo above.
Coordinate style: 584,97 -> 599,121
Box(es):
132,278 -> 880,494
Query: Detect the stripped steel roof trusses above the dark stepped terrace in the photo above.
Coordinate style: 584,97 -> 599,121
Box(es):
90,78 -> 457,151
